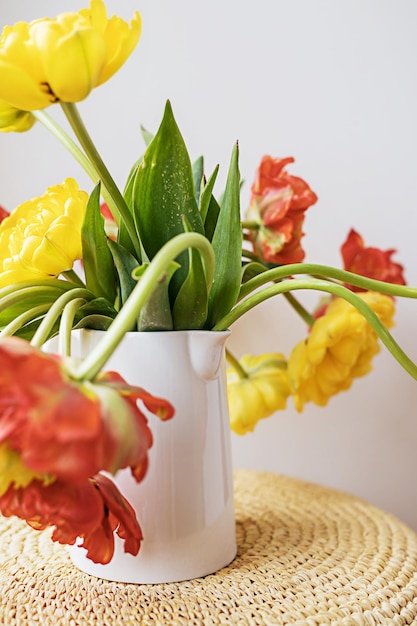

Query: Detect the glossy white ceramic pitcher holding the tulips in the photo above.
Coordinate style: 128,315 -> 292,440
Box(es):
70,330 -> 236,583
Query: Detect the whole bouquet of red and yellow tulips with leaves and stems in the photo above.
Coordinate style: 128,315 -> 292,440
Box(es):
0,0 -> 417,576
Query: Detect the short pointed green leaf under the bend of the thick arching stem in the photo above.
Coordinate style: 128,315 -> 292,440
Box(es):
172,219 -> 208,330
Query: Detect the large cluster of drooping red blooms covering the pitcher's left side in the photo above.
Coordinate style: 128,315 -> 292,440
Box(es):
0,337 -> 174,563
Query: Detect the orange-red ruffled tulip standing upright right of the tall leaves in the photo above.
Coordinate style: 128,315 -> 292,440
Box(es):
246,156 -> 317,264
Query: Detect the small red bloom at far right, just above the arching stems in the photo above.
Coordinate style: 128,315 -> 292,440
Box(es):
340,229 -> 406,291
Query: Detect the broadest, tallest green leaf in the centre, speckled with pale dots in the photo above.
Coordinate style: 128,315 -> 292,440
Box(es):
132,102 -> 204,299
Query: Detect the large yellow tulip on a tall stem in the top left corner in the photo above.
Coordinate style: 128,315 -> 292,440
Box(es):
0,0 -> 142,111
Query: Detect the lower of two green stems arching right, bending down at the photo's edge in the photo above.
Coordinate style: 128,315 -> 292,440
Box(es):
212,278 -> 417,380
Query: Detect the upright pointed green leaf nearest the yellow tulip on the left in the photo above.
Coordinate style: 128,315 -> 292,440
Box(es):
81,184 -> 116,302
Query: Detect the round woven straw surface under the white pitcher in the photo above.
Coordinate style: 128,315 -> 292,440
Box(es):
0,470 -> 417,626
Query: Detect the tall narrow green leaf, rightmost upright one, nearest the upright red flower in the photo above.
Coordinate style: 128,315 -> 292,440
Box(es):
206,144 -> 242,329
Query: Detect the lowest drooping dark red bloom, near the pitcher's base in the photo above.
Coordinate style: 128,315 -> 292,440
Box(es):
0,474 -> 142,563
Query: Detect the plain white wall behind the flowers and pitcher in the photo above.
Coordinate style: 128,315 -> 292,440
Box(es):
0,0 -> 417,530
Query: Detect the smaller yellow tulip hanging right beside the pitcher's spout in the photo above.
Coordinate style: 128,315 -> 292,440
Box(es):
227,353 -> 291,435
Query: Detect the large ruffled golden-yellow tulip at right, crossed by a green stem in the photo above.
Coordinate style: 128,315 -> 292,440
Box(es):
288,291 -> 395,411
